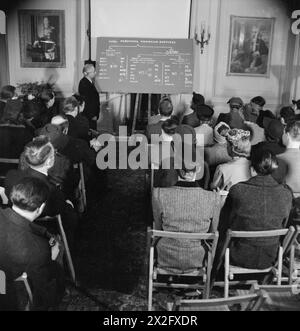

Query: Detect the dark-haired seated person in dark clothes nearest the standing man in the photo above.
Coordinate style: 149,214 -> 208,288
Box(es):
62,95 -> 89,141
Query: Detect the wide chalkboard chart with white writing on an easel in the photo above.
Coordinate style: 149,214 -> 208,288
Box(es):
96,38 -> 193,94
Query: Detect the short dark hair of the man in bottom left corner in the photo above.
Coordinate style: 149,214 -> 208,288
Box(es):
10,177 -> 49,212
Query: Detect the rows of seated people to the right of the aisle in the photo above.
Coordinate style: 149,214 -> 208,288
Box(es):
147,93 -> 300,282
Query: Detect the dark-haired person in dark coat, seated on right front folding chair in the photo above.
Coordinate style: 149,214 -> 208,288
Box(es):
219,150 -> 293,269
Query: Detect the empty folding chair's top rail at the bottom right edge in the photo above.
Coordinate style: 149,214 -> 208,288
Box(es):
173,291 -> 268,311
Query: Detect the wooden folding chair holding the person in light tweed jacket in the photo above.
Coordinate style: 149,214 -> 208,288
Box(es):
147,229 -> 219,311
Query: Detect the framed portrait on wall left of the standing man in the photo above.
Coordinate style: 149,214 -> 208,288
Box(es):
18,10 -> 66,68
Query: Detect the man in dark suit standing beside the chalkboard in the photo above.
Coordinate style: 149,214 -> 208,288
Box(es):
78,64 -> 100,130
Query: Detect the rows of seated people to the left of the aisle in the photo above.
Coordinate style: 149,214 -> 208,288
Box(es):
0,86 -> 104,310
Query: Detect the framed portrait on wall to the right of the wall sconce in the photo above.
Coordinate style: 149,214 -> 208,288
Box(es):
227,16 -> 275,77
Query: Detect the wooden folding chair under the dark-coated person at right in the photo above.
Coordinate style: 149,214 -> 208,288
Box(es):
224,227 -> 295,298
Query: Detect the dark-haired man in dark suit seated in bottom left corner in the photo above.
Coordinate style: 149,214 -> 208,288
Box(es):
0,178 -> 64,310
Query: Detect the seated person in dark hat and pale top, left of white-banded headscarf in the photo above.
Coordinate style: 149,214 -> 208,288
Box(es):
195,105 -> 214,147
